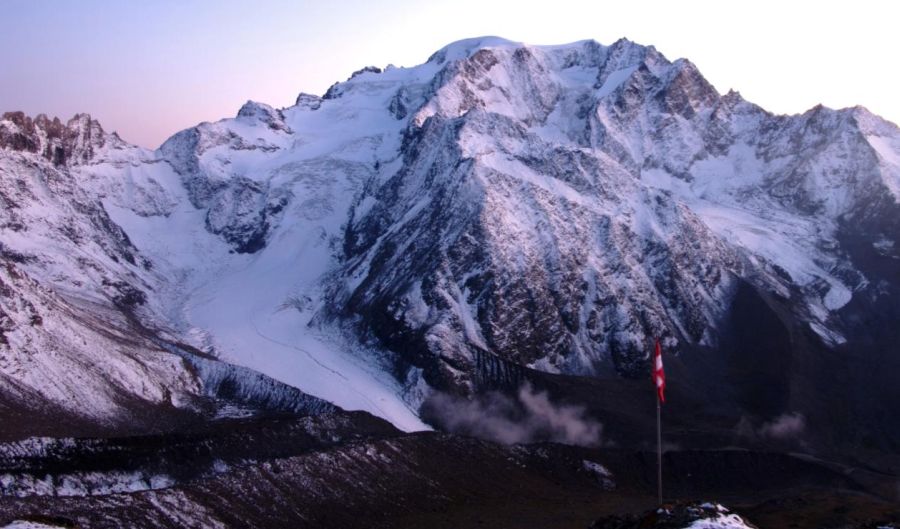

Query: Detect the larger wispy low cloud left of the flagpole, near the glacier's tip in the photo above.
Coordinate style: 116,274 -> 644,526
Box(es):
422,384 -> 603,446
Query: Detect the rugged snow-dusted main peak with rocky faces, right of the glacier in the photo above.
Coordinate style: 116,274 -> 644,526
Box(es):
333,37 -> 898,384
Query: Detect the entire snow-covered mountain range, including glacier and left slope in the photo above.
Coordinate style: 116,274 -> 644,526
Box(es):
0,38 -> 900,446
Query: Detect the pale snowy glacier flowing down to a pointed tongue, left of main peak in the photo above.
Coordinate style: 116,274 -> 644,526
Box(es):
95,92 -> 427,431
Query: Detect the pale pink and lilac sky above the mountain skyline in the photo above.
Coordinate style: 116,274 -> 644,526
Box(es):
0,0 -> 900,147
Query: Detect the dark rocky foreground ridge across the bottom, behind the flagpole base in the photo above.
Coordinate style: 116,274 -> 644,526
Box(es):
0,415 -> 900,529
